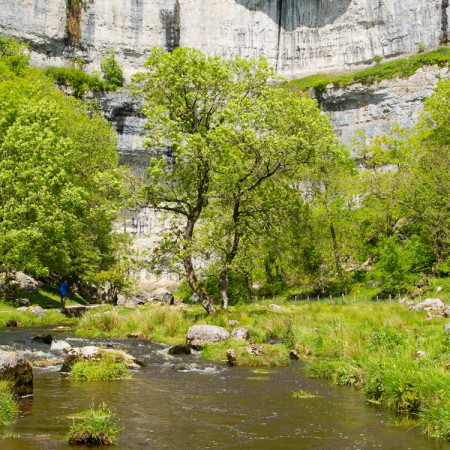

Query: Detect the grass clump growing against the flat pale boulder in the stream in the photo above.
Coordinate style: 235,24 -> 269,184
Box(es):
70,353 -> 130,381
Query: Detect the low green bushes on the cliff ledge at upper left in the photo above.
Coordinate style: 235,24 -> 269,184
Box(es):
45,67 -> 117,98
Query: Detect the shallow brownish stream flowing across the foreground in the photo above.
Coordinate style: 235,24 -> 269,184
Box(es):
0,328 -> 450,450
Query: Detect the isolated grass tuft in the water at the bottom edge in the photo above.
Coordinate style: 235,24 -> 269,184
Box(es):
69,403 -> 119,445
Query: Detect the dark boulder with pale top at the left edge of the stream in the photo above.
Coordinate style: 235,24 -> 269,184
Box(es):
0,350 -> 33,396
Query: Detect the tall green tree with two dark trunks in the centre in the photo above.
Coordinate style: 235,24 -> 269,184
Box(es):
135,48 -> 334,313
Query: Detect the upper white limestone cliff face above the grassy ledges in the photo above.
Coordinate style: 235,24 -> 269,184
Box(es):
0,0 -> 447,78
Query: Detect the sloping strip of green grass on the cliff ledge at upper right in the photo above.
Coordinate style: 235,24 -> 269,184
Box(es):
283,47 -> 450,94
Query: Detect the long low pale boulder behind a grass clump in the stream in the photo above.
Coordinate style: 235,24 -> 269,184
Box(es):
61,345 -> 145,372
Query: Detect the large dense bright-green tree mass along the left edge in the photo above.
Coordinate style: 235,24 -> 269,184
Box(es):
0,43 -> 121,288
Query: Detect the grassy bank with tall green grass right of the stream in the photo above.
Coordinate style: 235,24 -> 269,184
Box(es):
77,295 -> 450,439
